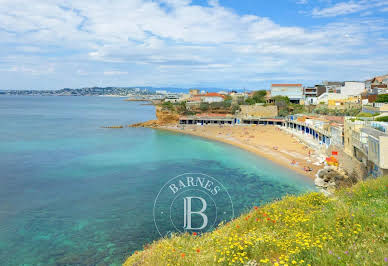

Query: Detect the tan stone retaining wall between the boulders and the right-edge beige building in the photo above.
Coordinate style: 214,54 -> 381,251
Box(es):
326,145 -> 367,181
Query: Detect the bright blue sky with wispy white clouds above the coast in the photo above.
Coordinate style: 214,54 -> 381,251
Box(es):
0,0 -> 388,89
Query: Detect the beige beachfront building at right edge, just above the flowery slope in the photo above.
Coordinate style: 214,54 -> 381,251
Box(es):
344,118 -> 388,176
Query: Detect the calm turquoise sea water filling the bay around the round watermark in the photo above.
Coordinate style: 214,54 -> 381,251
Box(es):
0,96 -> 313,265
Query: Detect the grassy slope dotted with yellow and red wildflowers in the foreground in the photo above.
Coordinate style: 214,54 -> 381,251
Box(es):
124,176 -> 388,265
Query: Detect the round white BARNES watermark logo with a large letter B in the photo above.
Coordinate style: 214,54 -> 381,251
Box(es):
153,173 -> 234,237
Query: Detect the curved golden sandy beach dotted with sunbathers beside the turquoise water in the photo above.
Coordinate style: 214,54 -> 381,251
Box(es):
158,125 -> 323,179
